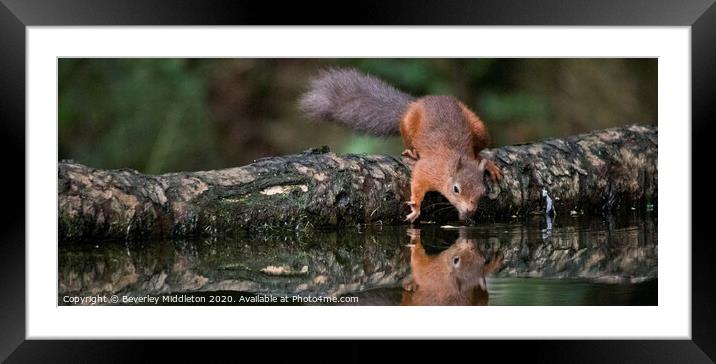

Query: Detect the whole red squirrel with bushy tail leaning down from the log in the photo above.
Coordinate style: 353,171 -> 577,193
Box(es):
299,69 -> 502,223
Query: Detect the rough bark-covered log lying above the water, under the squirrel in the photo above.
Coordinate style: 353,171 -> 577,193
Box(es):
58,126 -> 658,242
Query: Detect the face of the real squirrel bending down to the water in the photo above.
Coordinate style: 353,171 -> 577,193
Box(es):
443,157 -> 486,220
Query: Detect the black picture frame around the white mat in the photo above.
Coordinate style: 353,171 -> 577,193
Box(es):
0,0 -> 716,363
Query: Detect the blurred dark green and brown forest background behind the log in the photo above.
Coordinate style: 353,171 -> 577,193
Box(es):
58,58 -> 657,173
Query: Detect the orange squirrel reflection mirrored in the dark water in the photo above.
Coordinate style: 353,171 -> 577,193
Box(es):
400,229 -> 503,306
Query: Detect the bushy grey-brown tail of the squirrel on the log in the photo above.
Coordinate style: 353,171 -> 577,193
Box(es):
299,68 -> 412,135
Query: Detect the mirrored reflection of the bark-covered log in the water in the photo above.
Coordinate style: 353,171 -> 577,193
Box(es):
58,214 -> 658,305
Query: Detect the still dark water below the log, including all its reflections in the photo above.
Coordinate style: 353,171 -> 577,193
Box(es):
58,214 -> 658,305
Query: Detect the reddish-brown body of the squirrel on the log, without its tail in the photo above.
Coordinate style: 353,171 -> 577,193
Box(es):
400,96 -> 502,222
